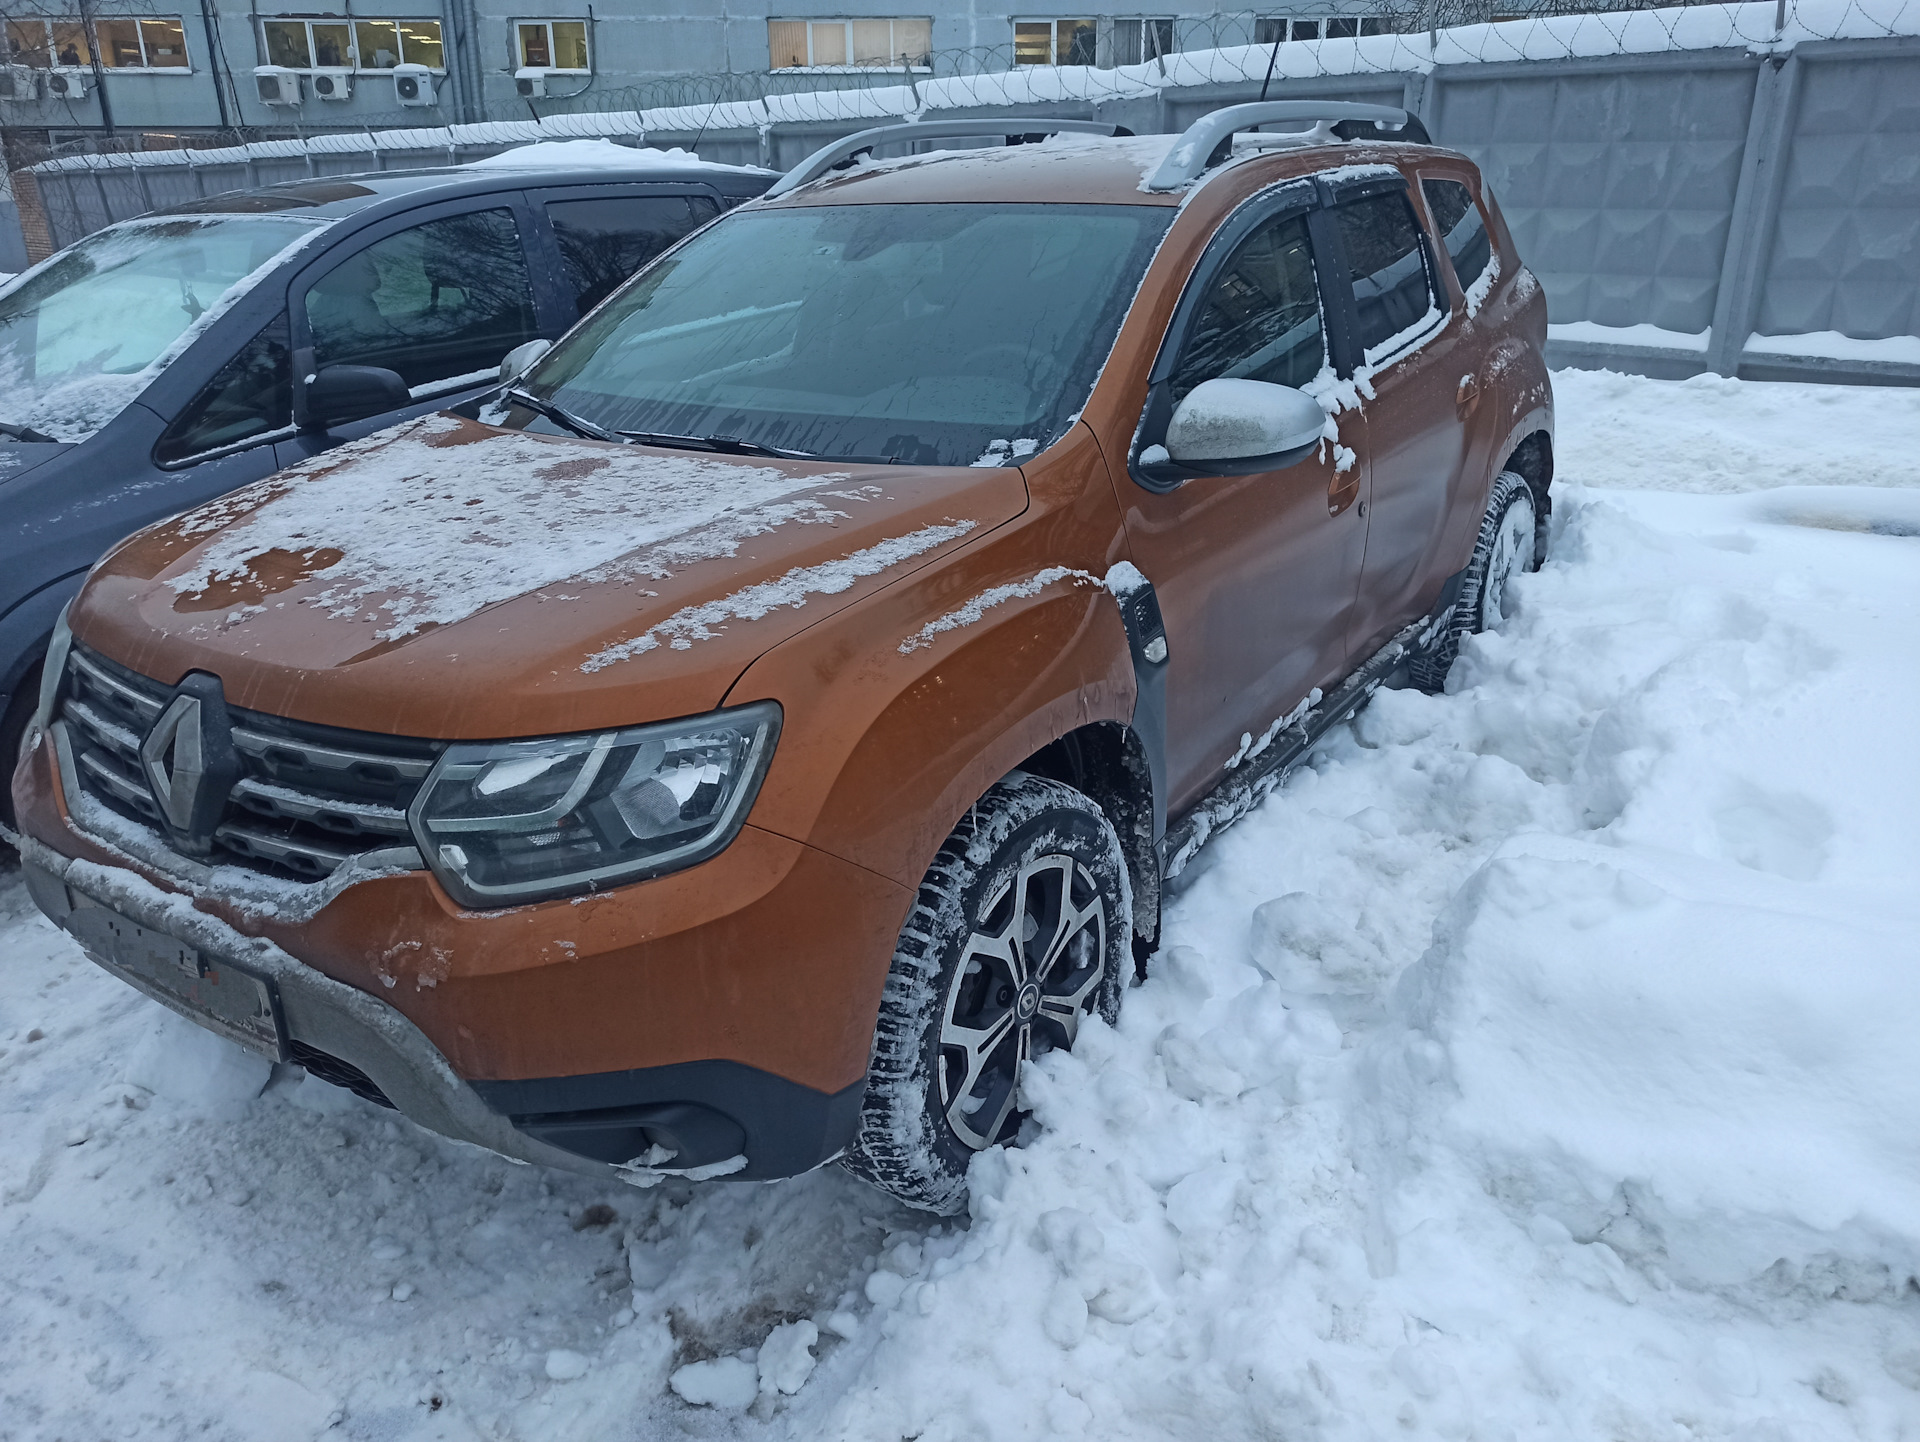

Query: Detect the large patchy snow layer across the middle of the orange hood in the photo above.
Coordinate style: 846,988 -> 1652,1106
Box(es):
167,415 -> 845,641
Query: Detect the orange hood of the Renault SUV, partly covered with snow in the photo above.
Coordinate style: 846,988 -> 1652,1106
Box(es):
73,415 -> 1027,739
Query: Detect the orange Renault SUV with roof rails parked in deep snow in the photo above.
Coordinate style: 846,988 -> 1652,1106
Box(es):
13,102 -> 1551,1212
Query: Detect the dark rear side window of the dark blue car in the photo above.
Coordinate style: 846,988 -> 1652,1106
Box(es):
528,184 -> 722,319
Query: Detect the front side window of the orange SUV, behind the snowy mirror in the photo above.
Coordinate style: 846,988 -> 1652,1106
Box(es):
1171,215 -> 1327,403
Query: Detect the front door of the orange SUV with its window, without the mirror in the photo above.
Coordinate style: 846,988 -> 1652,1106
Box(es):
1117,184 -> 1365,812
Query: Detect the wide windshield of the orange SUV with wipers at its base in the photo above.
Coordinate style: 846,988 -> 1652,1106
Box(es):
524,204 -> 1173,465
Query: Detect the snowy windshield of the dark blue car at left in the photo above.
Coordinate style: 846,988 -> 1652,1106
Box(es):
0,215 -> 319,442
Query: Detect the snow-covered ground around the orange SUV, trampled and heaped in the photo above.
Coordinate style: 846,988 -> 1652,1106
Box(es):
0,373 -> 1920,1442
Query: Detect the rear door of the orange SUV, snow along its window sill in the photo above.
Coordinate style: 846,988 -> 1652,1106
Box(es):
1329,167 -> 1475,662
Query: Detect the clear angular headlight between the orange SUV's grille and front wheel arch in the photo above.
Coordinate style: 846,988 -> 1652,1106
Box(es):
409,701 -> 780,906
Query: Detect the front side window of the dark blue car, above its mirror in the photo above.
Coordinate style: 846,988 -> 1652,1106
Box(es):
307,209 -> 540,388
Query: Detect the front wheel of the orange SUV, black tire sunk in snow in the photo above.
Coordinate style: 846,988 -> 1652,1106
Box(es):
845,772 -> 1133,1215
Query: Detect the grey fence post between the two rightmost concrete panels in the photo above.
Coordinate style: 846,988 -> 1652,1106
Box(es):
1707,54 -> 1801,376
